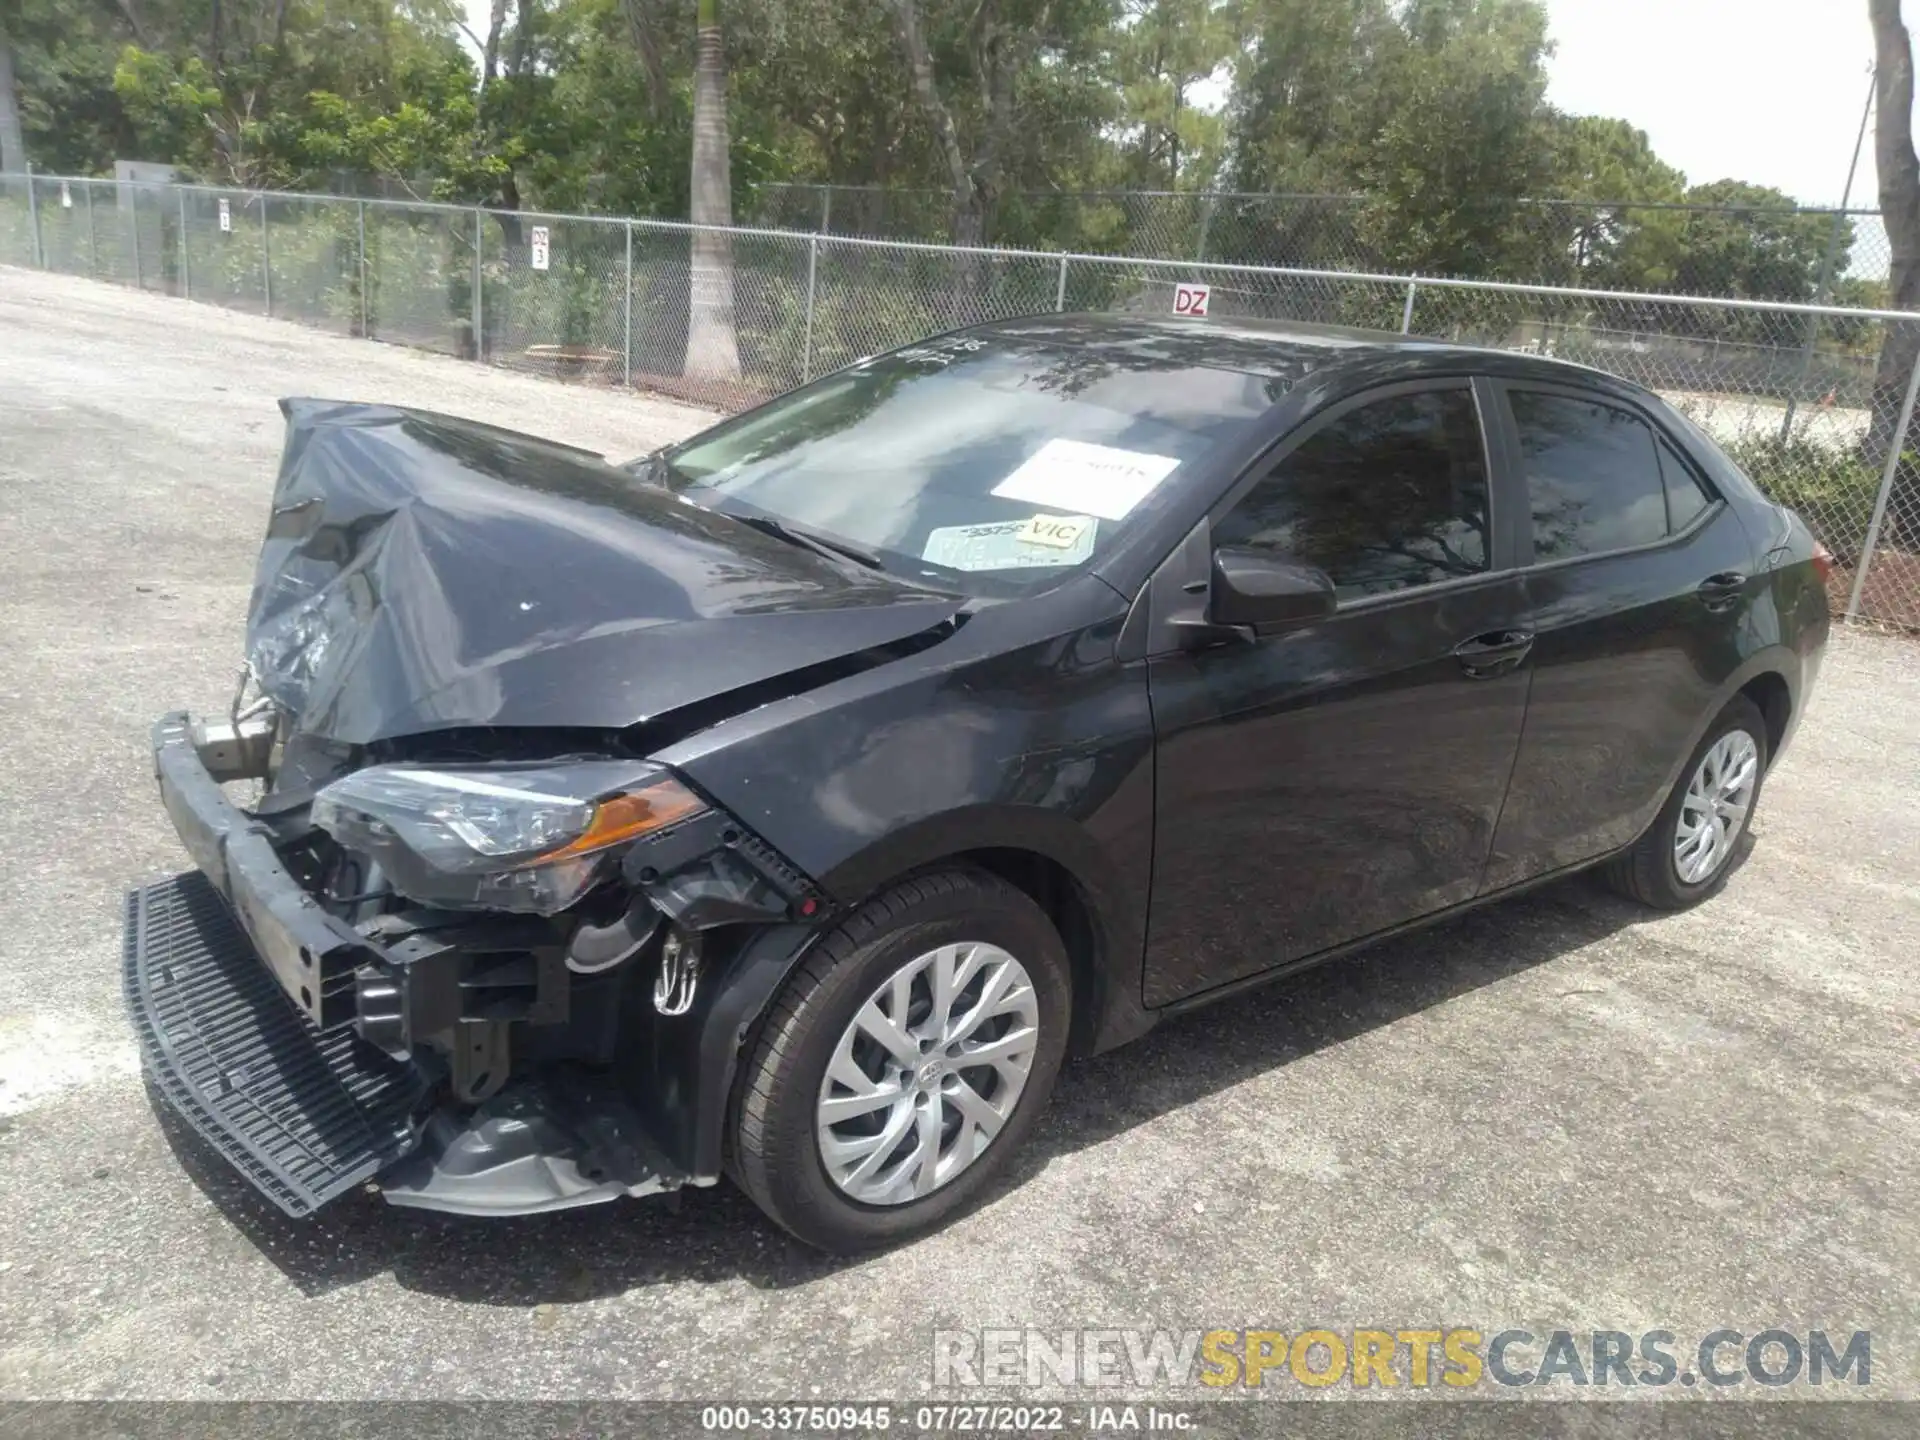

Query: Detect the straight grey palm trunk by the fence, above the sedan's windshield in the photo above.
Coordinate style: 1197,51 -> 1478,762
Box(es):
685,0 -> 739,380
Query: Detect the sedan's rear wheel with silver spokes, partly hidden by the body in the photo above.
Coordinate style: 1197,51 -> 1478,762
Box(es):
1605,695 -> 1766,910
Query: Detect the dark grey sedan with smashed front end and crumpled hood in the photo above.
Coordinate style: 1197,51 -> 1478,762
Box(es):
125,317 -> 1830,1250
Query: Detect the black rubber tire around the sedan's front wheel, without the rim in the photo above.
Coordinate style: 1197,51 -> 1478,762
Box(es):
730,870 -> 1071,1254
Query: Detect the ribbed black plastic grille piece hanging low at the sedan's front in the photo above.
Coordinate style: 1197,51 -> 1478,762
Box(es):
123,872 -> 426,1215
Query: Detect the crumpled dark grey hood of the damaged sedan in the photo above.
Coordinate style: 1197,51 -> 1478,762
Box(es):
248,399 -> 960,745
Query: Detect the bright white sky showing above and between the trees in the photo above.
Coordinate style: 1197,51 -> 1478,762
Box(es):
465,0 -> 1889,207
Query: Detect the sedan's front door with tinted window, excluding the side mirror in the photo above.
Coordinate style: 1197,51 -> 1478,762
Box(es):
1144,378 -> 1528,1004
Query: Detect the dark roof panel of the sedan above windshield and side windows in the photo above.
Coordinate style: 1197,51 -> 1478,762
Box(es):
968,311 -> 1640,401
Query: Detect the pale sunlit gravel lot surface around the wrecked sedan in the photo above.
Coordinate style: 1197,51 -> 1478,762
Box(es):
0,269 -> 1920,1400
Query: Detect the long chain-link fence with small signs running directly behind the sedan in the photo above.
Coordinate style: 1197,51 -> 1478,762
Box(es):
0,177 -> 1920,630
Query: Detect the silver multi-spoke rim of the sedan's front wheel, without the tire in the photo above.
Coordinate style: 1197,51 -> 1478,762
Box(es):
814,941 -> 1041,1206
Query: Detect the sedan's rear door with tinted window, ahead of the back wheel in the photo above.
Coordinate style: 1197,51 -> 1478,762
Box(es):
1484,380 -> 1757,891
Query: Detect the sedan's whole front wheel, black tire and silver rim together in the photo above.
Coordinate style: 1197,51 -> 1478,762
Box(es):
732,870 -> 1071,1254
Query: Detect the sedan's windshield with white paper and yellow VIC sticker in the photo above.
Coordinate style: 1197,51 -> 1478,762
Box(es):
664,334 -> 1273,595
